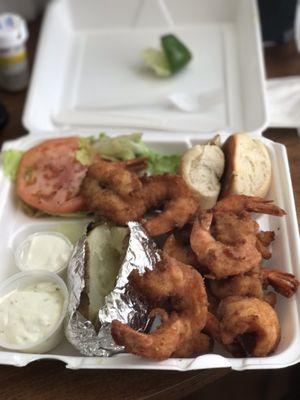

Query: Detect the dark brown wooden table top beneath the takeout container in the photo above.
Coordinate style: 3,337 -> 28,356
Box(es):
0,17 -> 300,400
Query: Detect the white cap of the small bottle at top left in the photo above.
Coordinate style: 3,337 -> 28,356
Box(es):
0,13 -> 28,50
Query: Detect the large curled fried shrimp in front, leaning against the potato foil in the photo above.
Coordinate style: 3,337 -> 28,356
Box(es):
111,255 -> 207,360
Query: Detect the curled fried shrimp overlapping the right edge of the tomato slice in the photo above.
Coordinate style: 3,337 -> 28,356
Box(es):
81,160 -> 145,225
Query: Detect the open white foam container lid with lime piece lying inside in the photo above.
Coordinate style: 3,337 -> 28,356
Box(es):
23,0 -> 266,133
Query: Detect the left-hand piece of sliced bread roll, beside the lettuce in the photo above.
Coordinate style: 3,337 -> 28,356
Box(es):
179,140 -> 225,209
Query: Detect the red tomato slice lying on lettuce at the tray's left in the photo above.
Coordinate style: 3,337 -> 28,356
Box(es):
17,137 -> 87,214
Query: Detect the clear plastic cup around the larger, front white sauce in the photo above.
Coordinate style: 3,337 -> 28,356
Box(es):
0,271 -> 69,353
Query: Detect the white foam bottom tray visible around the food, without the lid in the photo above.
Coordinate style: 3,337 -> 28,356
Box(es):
0,130 -> 300,371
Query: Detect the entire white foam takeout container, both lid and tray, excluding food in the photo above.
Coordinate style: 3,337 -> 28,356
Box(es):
0,0 -> 300,371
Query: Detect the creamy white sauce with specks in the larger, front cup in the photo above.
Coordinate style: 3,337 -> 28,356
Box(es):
0,281 -> 64,346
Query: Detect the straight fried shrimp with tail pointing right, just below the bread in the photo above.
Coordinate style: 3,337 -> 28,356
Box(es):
214,194 -> 286,217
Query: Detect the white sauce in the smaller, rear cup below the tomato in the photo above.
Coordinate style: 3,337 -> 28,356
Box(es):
16,232 -> 72,272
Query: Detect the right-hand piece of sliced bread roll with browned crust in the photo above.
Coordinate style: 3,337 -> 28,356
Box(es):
221,133 -> 272,197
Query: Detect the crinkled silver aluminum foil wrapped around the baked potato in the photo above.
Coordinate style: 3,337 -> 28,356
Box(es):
65,222 -> 160,357
